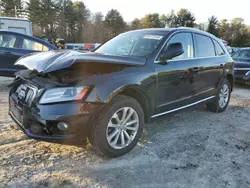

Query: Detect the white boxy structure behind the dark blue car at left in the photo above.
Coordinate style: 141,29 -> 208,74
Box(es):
0,17 -> 33,36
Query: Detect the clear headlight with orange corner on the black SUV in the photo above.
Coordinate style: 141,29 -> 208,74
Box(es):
39,87 -> 89,104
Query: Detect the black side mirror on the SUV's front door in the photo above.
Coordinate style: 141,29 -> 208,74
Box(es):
161,42 -> 184,61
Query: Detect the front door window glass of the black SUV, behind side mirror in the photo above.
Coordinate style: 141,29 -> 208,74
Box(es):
157,33 -> 194,61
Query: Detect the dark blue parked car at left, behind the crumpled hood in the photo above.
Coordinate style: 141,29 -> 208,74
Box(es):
0,31 -> 57,77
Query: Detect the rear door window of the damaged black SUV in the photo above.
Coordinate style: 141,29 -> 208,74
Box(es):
194,34 -> 215,57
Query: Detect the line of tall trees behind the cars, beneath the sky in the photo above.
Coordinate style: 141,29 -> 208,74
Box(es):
0,0 -> 250,47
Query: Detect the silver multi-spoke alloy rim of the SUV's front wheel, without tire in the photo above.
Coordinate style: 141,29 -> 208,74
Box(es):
106,107 -> 139,149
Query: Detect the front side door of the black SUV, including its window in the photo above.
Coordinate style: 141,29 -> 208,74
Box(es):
155,32 -> 196,114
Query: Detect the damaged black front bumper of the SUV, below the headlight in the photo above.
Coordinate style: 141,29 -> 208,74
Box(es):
9,81 -> 103,143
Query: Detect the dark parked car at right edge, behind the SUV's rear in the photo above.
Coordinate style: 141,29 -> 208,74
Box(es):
232,48 -> 250,83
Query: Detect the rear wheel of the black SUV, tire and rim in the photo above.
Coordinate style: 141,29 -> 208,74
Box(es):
206,79 -> 232,113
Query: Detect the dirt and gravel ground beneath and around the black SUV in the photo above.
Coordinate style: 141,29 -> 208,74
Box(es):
0,80 -> 250,188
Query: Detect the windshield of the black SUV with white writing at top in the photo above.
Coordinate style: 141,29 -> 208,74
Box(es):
96,31 -> 166,57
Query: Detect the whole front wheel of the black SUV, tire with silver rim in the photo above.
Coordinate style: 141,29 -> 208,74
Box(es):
89,95 -> 144,157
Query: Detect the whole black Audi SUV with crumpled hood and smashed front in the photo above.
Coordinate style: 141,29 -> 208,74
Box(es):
9,28 -> 234,157
